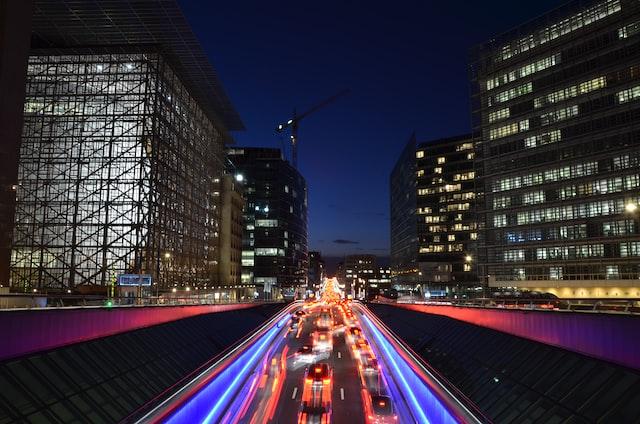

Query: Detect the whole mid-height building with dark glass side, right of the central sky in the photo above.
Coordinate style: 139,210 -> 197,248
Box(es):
391,135 -> 479,290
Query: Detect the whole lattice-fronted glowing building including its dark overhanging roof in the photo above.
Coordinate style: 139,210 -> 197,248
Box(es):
11,0 -> 242,292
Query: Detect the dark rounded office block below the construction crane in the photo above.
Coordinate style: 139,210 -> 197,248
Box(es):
227,147 -> 309,297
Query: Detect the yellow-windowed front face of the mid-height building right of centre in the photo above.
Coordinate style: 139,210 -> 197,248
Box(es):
416,135 -> 478,286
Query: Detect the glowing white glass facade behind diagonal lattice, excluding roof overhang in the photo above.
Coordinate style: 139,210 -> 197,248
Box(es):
11,53 -> 226,291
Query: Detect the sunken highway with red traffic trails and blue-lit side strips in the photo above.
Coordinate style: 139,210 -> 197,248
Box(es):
140,280 -> 480,424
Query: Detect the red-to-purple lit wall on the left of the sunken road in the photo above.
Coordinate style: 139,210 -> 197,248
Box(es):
0,303 -> 257,360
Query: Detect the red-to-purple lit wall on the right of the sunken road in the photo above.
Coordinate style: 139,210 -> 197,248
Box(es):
394,304 -> 640,369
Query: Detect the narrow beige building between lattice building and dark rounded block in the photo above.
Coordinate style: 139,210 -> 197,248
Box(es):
214,174 -> 244,285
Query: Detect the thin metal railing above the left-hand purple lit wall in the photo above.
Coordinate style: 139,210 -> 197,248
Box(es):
0,293 -> 283,310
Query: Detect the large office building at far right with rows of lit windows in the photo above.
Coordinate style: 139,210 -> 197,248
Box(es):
472,0 -> 640,297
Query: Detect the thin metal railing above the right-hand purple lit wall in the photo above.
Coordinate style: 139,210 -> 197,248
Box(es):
373,297 -> 640,314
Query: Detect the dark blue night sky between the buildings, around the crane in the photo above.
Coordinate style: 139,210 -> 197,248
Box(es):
180,0 -> 561,256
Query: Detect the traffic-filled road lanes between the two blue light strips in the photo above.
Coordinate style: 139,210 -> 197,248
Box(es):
240,294 -> 397,424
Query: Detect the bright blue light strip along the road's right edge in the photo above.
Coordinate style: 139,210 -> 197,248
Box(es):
361,314 -> 457,424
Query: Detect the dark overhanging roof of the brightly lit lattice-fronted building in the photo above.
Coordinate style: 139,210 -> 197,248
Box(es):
32,0 -> 244,131
